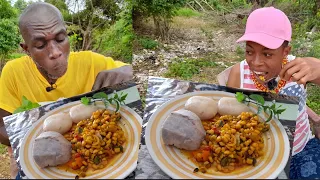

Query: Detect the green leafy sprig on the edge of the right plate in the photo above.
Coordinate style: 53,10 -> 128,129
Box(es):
236,92 -> 286,122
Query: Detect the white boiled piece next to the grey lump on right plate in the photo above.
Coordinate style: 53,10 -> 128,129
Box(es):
185,96 -> 218,120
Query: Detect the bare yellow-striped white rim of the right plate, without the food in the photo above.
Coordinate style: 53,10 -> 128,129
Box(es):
145,91 -> 290,179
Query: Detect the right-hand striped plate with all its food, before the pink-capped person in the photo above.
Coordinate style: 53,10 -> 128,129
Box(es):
145,91 -> 290,179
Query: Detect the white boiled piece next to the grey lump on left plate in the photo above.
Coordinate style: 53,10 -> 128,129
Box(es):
43,112 -> 72,134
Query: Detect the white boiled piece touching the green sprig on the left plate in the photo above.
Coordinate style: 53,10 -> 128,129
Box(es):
69,104 -> 100,123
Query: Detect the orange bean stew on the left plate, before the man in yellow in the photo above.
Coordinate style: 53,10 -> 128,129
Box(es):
64,109 -> 126,177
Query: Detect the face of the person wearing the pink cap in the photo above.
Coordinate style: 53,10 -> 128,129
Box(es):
246,41 -> 290,81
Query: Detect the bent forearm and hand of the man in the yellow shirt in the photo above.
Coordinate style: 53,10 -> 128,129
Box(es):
92,65 -> 133,91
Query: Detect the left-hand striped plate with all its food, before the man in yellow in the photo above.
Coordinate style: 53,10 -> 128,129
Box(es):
19,101 -> 142,179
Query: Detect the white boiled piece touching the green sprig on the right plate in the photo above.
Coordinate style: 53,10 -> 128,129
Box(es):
218,97 -> 251,116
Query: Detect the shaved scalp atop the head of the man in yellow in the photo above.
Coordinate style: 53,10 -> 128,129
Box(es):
19,2 -> 64,39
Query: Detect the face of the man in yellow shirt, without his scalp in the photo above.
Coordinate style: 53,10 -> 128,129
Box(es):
21,17 -> 70,79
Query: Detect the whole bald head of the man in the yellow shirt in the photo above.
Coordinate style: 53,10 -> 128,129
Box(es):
19,2 -> 70,81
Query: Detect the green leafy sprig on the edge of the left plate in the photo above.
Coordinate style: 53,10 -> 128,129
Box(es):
81,92 -> 128,112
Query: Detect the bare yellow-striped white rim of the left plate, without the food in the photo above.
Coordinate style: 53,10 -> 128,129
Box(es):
20,101 -> 142,179
